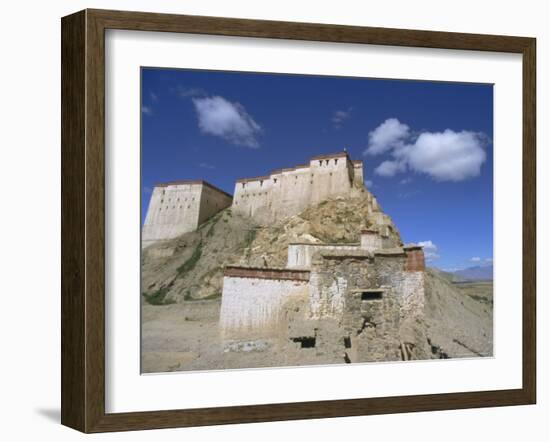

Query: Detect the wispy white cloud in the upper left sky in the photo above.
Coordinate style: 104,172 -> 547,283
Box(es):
193,96 -> 262,148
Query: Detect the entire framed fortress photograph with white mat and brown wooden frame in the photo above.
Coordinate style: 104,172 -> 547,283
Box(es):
61,10 -> 536,432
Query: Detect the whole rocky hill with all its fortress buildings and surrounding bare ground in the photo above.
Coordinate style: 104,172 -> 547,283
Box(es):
141,152 -> 492,373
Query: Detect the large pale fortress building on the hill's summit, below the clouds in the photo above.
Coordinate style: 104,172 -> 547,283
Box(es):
232,152 -> 364,224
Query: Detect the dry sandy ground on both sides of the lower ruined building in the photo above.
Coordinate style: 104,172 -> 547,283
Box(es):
142,274 -> 493,373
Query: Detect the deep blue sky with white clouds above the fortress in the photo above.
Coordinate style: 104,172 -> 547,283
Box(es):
141,68 -> 493,269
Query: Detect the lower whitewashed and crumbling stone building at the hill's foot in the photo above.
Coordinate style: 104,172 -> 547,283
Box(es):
220,226 -> 425,364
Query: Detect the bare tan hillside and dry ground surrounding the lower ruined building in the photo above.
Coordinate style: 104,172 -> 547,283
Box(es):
141,198 -> 493,373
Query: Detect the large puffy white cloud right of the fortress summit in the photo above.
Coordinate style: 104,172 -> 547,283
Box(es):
365,118 -> 487,181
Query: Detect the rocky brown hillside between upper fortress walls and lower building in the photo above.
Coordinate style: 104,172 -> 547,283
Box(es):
142,193 -> 400,304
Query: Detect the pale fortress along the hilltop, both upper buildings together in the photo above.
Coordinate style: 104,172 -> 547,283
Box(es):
142,151 -> 384,247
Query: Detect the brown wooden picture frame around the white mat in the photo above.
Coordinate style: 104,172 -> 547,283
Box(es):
61,10 -> 536,432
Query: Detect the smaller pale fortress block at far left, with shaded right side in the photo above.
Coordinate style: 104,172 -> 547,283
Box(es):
141,180 -> 232,247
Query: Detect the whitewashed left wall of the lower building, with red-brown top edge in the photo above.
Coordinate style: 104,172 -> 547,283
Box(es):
220,267 -> 309,333
